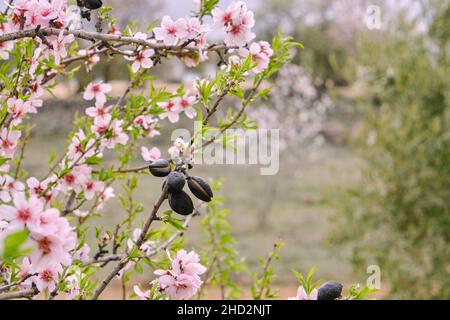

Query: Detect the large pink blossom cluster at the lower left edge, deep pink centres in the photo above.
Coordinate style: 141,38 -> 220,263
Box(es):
0,192 -> 77,291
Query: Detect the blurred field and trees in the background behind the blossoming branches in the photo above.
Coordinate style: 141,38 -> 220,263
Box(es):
12,0 -> 450,299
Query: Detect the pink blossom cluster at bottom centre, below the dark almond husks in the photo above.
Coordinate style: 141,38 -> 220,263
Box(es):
151,250 -> 206,300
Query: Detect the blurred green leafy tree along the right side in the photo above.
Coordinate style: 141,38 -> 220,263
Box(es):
330,0 -> 450,299
